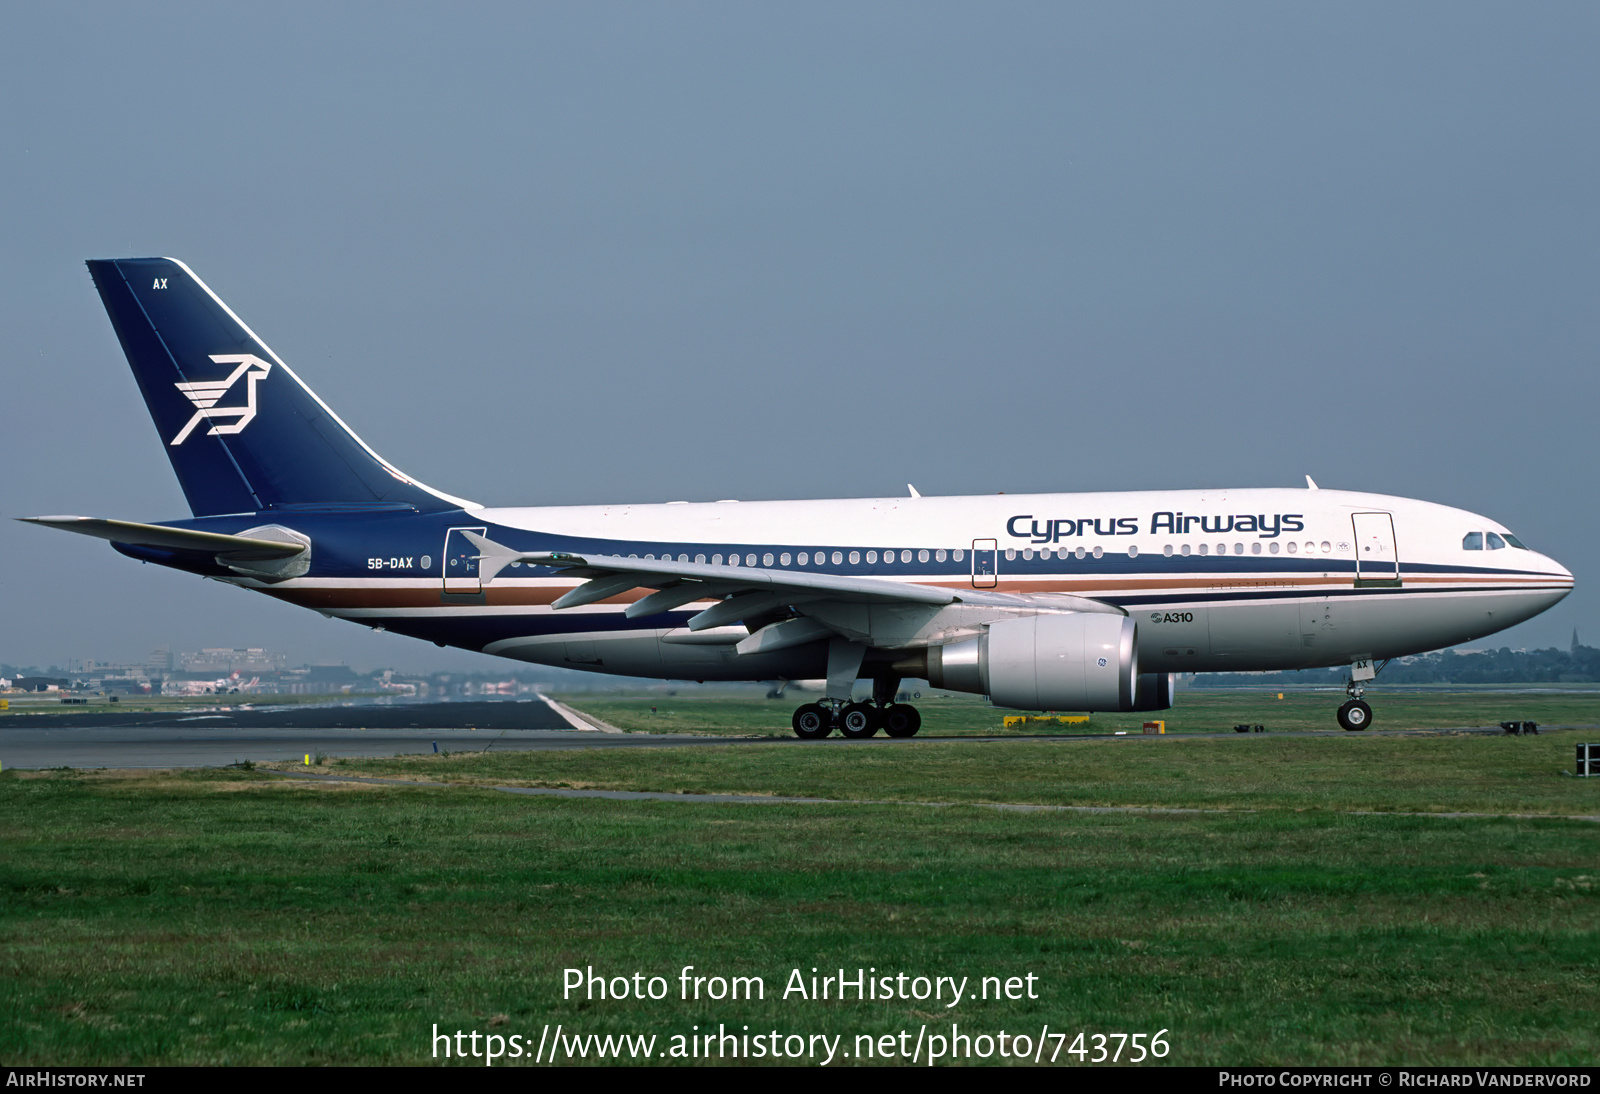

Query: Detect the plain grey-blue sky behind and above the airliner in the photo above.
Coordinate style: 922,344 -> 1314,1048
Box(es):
0,3 -> 1600,667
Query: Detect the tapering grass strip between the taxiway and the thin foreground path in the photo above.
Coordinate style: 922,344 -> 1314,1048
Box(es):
318,731 -> 1600,816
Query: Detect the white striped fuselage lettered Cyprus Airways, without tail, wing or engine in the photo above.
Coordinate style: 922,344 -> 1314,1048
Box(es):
281,489 -> 1573,680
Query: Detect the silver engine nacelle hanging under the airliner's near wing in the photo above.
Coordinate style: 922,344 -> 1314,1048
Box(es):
928,613 -> 1139,710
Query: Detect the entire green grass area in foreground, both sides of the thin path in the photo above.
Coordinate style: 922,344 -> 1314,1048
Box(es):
0,722 -> 1600,1065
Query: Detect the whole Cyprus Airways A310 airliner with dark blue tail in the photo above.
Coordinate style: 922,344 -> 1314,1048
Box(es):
26,259 -> 1573,737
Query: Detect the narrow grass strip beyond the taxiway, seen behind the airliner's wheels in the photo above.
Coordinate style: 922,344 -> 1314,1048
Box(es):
557,688 -> 1600,736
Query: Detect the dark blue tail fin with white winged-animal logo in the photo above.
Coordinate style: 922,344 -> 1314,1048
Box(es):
88,259 -> 470,517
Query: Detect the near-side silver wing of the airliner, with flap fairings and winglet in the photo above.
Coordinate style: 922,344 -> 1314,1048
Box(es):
462,531 -> 1126,648
